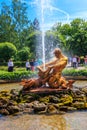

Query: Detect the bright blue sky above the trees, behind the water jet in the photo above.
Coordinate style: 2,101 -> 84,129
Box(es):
0,0 -> 87,28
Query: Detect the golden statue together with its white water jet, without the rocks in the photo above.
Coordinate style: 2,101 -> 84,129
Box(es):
21,0 -> 74,91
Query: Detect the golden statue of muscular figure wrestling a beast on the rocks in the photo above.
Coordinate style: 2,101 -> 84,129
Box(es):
22,48 -> 73,90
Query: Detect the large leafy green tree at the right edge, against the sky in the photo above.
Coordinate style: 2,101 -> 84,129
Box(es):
54,18 -> 87,56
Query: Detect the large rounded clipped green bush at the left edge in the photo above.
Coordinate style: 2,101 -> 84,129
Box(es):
0,42 -> 17,61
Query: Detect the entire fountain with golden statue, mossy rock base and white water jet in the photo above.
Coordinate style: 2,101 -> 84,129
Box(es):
0,0 -> 87,115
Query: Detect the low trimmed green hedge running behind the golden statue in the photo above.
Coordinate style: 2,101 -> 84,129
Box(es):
0,68 -> 87,81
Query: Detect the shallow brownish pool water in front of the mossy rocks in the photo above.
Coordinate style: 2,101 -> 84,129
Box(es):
0,111 -> 87,130
